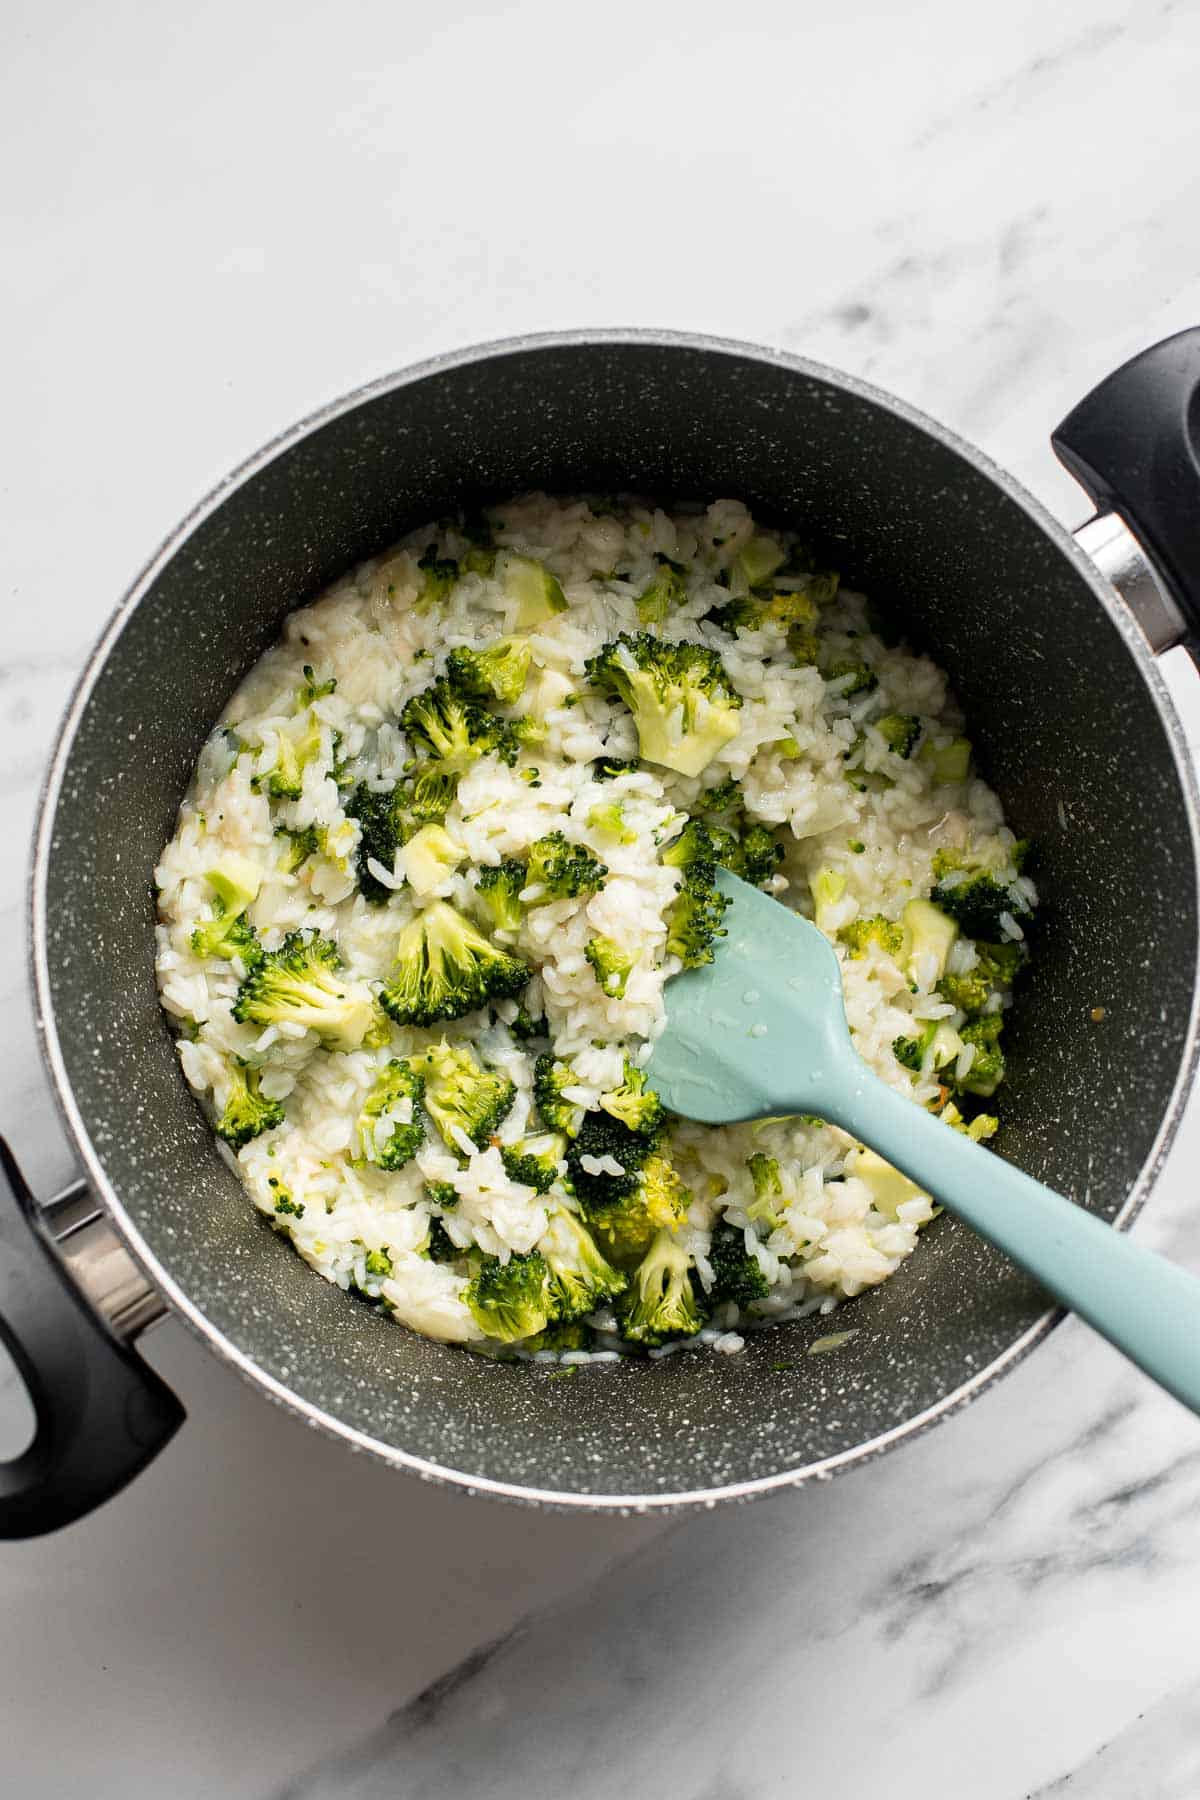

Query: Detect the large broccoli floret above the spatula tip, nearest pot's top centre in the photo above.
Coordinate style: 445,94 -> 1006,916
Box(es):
587,632 -> 741,776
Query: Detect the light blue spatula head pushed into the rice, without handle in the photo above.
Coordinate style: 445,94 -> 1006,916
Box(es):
648,869 -> 862,1125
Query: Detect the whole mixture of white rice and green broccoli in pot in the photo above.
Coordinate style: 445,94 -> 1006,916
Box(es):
157,495 -> 1036,1359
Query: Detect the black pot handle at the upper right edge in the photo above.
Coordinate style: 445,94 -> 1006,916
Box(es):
1051,326 -> 1200,653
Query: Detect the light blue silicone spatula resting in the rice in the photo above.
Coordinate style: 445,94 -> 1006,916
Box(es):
648,869 -> 1200,1411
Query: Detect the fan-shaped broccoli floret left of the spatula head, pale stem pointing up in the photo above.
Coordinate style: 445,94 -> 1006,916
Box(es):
380,900 -> 529,1024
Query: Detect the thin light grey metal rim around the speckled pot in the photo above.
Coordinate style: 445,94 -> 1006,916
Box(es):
29,328 -> 1200,1514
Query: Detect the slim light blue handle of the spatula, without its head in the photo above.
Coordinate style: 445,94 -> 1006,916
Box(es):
826,1064 -> 1200,1413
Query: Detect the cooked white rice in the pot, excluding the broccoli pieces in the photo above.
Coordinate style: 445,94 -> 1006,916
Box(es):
157,495 -> 1036,1359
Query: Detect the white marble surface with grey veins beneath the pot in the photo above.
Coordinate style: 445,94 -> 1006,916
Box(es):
0,0 -> 1200,1800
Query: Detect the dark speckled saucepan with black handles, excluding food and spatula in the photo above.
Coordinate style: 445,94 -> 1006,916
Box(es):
0,329 -> 1200,1537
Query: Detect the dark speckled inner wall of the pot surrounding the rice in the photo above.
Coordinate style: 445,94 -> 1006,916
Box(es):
35,338 -> 1200,1503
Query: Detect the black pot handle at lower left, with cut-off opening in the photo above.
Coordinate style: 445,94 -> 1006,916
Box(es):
0,1139 -> 184,1539
